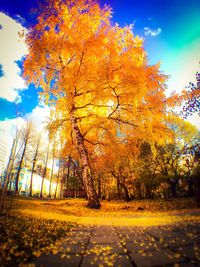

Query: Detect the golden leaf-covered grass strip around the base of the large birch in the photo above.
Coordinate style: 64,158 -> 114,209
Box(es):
3,197 -> 198,226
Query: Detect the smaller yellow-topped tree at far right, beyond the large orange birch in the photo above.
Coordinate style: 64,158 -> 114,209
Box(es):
155,116 -> 199,197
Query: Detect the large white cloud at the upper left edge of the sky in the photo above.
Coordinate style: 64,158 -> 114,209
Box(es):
0,12 -> 28,102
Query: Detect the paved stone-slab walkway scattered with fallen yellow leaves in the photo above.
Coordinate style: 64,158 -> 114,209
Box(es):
35,223 -> 200,267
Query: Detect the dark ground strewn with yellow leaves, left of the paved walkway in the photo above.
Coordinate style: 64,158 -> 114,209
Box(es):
0,215 -> 72,266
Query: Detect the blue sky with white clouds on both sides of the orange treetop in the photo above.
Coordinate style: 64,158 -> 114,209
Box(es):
0,0 -> 200,127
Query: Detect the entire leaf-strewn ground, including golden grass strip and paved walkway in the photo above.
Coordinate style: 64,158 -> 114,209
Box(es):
0,197 -> 200,267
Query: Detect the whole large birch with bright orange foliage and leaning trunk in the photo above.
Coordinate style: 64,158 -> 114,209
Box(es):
24,0 -> 165,208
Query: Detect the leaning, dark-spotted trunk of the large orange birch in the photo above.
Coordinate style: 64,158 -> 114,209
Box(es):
70,110 -> 100,209
